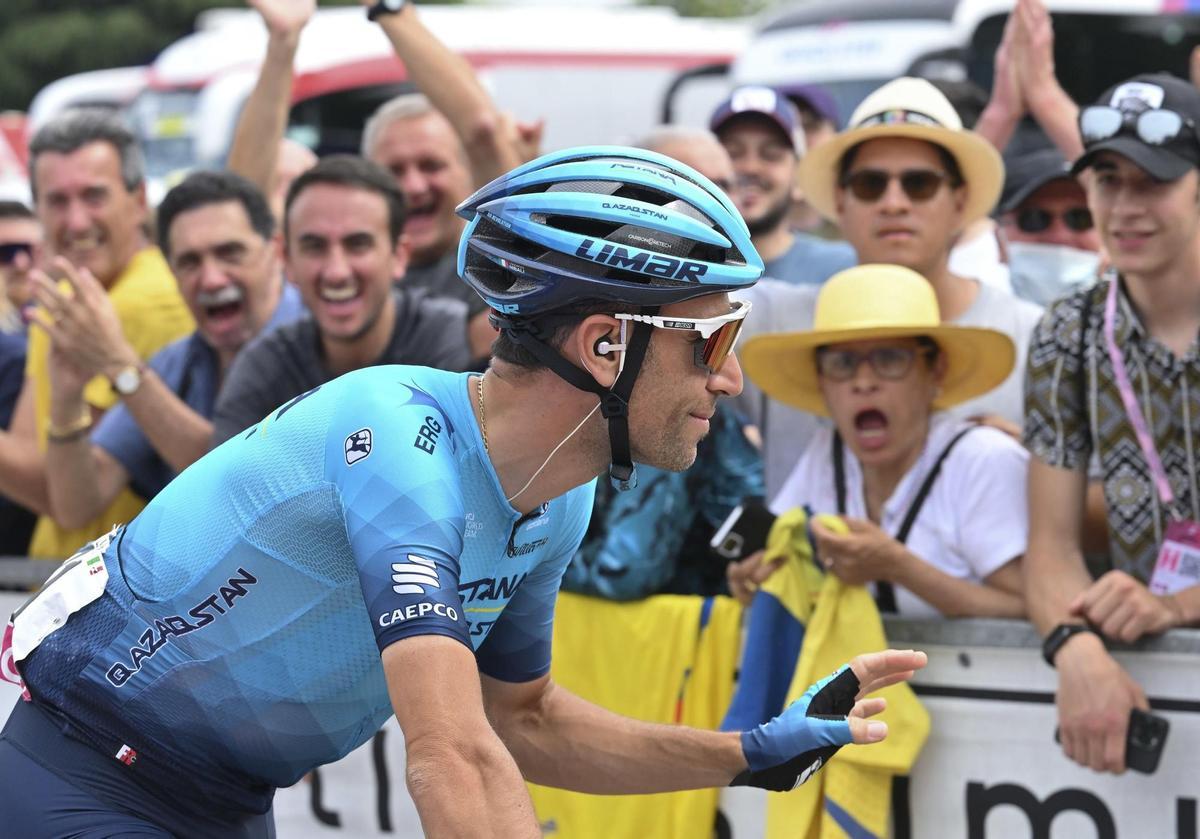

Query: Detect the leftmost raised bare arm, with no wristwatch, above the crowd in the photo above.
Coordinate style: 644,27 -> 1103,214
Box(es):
226,0 -> 317,214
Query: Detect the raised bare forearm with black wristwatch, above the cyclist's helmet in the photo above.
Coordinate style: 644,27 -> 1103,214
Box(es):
364,0 -> 524,185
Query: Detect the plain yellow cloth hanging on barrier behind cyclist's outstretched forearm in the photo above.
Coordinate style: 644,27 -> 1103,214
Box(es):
529,592 -> 742,839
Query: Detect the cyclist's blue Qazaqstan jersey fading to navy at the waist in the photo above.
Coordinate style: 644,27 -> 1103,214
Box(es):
14,366 -> 594,813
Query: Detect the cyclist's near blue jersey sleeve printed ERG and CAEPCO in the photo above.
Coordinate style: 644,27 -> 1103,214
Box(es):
325,385 -> 472,651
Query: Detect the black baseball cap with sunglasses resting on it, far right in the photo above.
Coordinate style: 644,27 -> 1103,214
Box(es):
1072,73 -> 1200,181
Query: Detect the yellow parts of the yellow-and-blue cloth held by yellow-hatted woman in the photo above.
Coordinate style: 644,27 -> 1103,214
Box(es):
763,509 -> 929,839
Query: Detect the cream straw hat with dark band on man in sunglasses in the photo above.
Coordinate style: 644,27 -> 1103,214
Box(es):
799,77 -> 1004,227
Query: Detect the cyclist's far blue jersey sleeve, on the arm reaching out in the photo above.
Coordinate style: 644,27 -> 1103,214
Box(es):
475,481 -> 595,682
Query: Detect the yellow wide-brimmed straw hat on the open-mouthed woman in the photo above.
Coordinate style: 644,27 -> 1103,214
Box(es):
738,265 -> 1016,415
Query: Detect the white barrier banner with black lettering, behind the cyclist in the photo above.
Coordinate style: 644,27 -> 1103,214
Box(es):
0,593 -> 1200,839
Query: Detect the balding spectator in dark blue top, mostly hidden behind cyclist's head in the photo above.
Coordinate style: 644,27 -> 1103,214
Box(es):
563,126 -> 764,600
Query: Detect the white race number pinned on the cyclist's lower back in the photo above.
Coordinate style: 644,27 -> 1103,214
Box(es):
6,527 -> 116,669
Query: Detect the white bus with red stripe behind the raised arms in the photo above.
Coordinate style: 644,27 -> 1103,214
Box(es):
130,5 -> 752,198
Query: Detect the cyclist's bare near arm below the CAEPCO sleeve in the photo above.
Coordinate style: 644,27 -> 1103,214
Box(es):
383,635 -> 541,839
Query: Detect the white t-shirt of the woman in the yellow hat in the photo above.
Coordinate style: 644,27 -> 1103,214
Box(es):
770,413 -> 1030,617
